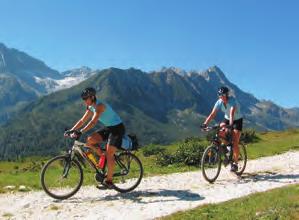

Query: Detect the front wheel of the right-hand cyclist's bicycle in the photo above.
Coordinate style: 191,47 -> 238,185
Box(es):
201,146 -> 221,183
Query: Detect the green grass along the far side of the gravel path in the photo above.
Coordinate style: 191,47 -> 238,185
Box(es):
0,130 -> 299,193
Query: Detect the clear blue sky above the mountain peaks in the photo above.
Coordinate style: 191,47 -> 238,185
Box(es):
0,0 -> 299,107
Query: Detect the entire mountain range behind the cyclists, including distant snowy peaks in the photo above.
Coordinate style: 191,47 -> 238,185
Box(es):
0,42 -> 299,159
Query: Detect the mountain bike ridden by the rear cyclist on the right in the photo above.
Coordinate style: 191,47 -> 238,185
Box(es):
201,125 -> 247,183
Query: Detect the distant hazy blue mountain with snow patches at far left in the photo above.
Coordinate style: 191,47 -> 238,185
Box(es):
0,43 -> 93,125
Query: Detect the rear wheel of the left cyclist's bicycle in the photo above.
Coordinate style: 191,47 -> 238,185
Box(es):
113,152 -> 143,193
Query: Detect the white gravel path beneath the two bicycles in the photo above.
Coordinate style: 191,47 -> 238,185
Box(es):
0,151 -> 299,220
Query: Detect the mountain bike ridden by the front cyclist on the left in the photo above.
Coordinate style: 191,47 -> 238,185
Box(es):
41,131 -> 143,200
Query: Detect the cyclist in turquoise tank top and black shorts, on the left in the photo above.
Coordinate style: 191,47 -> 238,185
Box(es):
71,88 -> 125,188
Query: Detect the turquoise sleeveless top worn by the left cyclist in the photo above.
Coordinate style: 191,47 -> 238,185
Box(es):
88,101 -> 122,127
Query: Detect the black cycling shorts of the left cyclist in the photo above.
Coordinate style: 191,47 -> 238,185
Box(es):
96,123 -> 126,149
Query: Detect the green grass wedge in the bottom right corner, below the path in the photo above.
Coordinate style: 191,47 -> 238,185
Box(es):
161,184 -> 299,220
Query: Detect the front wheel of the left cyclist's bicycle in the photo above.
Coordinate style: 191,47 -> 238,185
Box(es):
41,155 -> 83,199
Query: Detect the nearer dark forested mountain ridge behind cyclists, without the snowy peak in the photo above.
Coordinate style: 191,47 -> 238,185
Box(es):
0,66 -> 299,159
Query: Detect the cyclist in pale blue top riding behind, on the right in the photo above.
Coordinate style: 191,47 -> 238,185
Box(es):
202,87 -> 243,172
